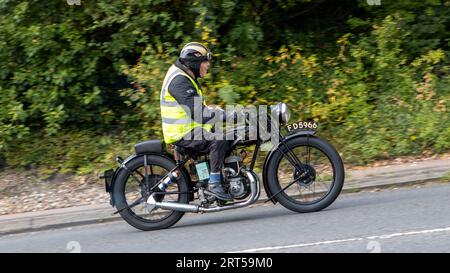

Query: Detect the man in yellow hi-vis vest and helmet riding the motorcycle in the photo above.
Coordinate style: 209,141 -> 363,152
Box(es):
160,42 -> 233,200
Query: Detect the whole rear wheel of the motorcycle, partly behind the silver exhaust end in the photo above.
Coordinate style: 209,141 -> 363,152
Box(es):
113,155 -> 189,228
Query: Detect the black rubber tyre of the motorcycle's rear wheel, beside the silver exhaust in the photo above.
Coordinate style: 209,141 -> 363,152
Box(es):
113,155 -> 189,228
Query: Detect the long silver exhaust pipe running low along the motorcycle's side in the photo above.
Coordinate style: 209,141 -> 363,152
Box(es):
147,170 -> 260,213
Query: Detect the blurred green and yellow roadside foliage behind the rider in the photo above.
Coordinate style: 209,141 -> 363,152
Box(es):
0,0 -> 450,173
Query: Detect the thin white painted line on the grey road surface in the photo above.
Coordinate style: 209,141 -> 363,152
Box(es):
228,224 -> 450,253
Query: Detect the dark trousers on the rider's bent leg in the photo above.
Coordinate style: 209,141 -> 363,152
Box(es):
174,129 -> 230,170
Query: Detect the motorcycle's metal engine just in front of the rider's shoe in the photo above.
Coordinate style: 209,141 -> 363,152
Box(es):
223,155 -> 250,199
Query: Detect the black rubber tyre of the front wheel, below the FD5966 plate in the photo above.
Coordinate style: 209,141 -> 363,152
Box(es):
267,136 -> 345,213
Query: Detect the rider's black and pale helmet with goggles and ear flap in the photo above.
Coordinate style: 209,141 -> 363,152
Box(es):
179,42 -> 212,77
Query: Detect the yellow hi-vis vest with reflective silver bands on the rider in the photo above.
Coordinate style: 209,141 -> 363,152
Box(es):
160,65 -> 212,144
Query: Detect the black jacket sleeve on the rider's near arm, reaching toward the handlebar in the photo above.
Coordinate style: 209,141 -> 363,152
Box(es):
168,75 -> 215,124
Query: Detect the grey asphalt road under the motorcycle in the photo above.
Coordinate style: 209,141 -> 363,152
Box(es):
0,184 -> 450,253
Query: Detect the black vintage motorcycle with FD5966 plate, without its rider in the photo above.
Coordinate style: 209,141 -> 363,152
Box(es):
101,103 -> 345,230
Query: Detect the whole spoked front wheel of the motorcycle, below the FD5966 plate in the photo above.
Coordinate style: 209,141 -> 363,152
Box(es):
267,136 -> 345,212
